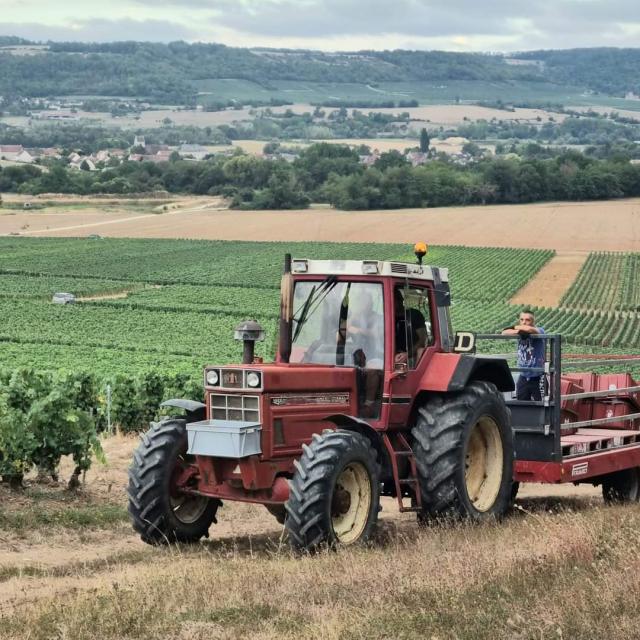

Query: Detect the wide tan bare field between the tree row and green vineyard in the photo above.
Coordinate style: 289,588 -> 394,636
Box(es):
5,197 -> 640,251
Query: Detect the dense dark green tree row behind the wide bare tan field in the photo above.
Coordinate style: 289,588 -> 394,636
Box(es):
0,143 -> 640,209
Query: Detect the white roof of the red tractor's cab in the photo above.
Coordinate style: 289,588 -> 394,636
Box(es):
291,258 -> 449,282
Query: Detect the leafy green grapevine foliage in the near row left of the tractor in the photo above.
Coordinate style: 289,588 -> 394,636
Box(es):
0,369 -> 202,486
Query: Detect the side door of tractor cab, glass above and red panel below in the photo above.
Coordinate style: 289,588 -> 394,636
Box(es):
389,282 -> 438,426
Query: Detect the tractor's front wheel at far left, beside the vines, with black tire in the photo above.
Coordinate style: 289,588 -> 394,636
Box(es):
127,418 -> 222,545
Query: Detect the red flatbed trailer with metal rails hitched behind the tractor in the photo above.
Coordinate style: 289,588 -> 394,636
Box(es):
508,348 -> 640,501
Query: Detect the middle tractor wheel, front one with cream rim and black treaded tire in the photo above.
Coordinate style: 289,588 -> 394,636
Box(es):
285,429 -> 380,551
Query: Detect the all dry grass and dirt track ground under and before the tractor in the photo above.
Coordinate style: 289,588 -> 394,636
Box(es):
0,437 -> 640,640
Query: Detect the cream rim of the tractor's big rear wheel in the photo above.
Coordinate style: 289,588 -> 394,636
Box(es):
465,416 -> 503,511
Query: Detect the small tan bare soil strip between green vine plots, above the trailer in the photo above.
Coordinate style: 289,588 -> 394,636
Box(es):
509,251 -> 589,307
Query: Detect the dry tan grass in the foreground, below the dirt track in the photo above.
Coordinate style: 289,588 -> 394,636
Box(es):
4,508 -> 640,639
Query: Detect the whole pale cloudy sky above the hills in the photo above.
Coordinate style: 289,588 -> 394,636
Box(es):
0,0 -> 640,51
